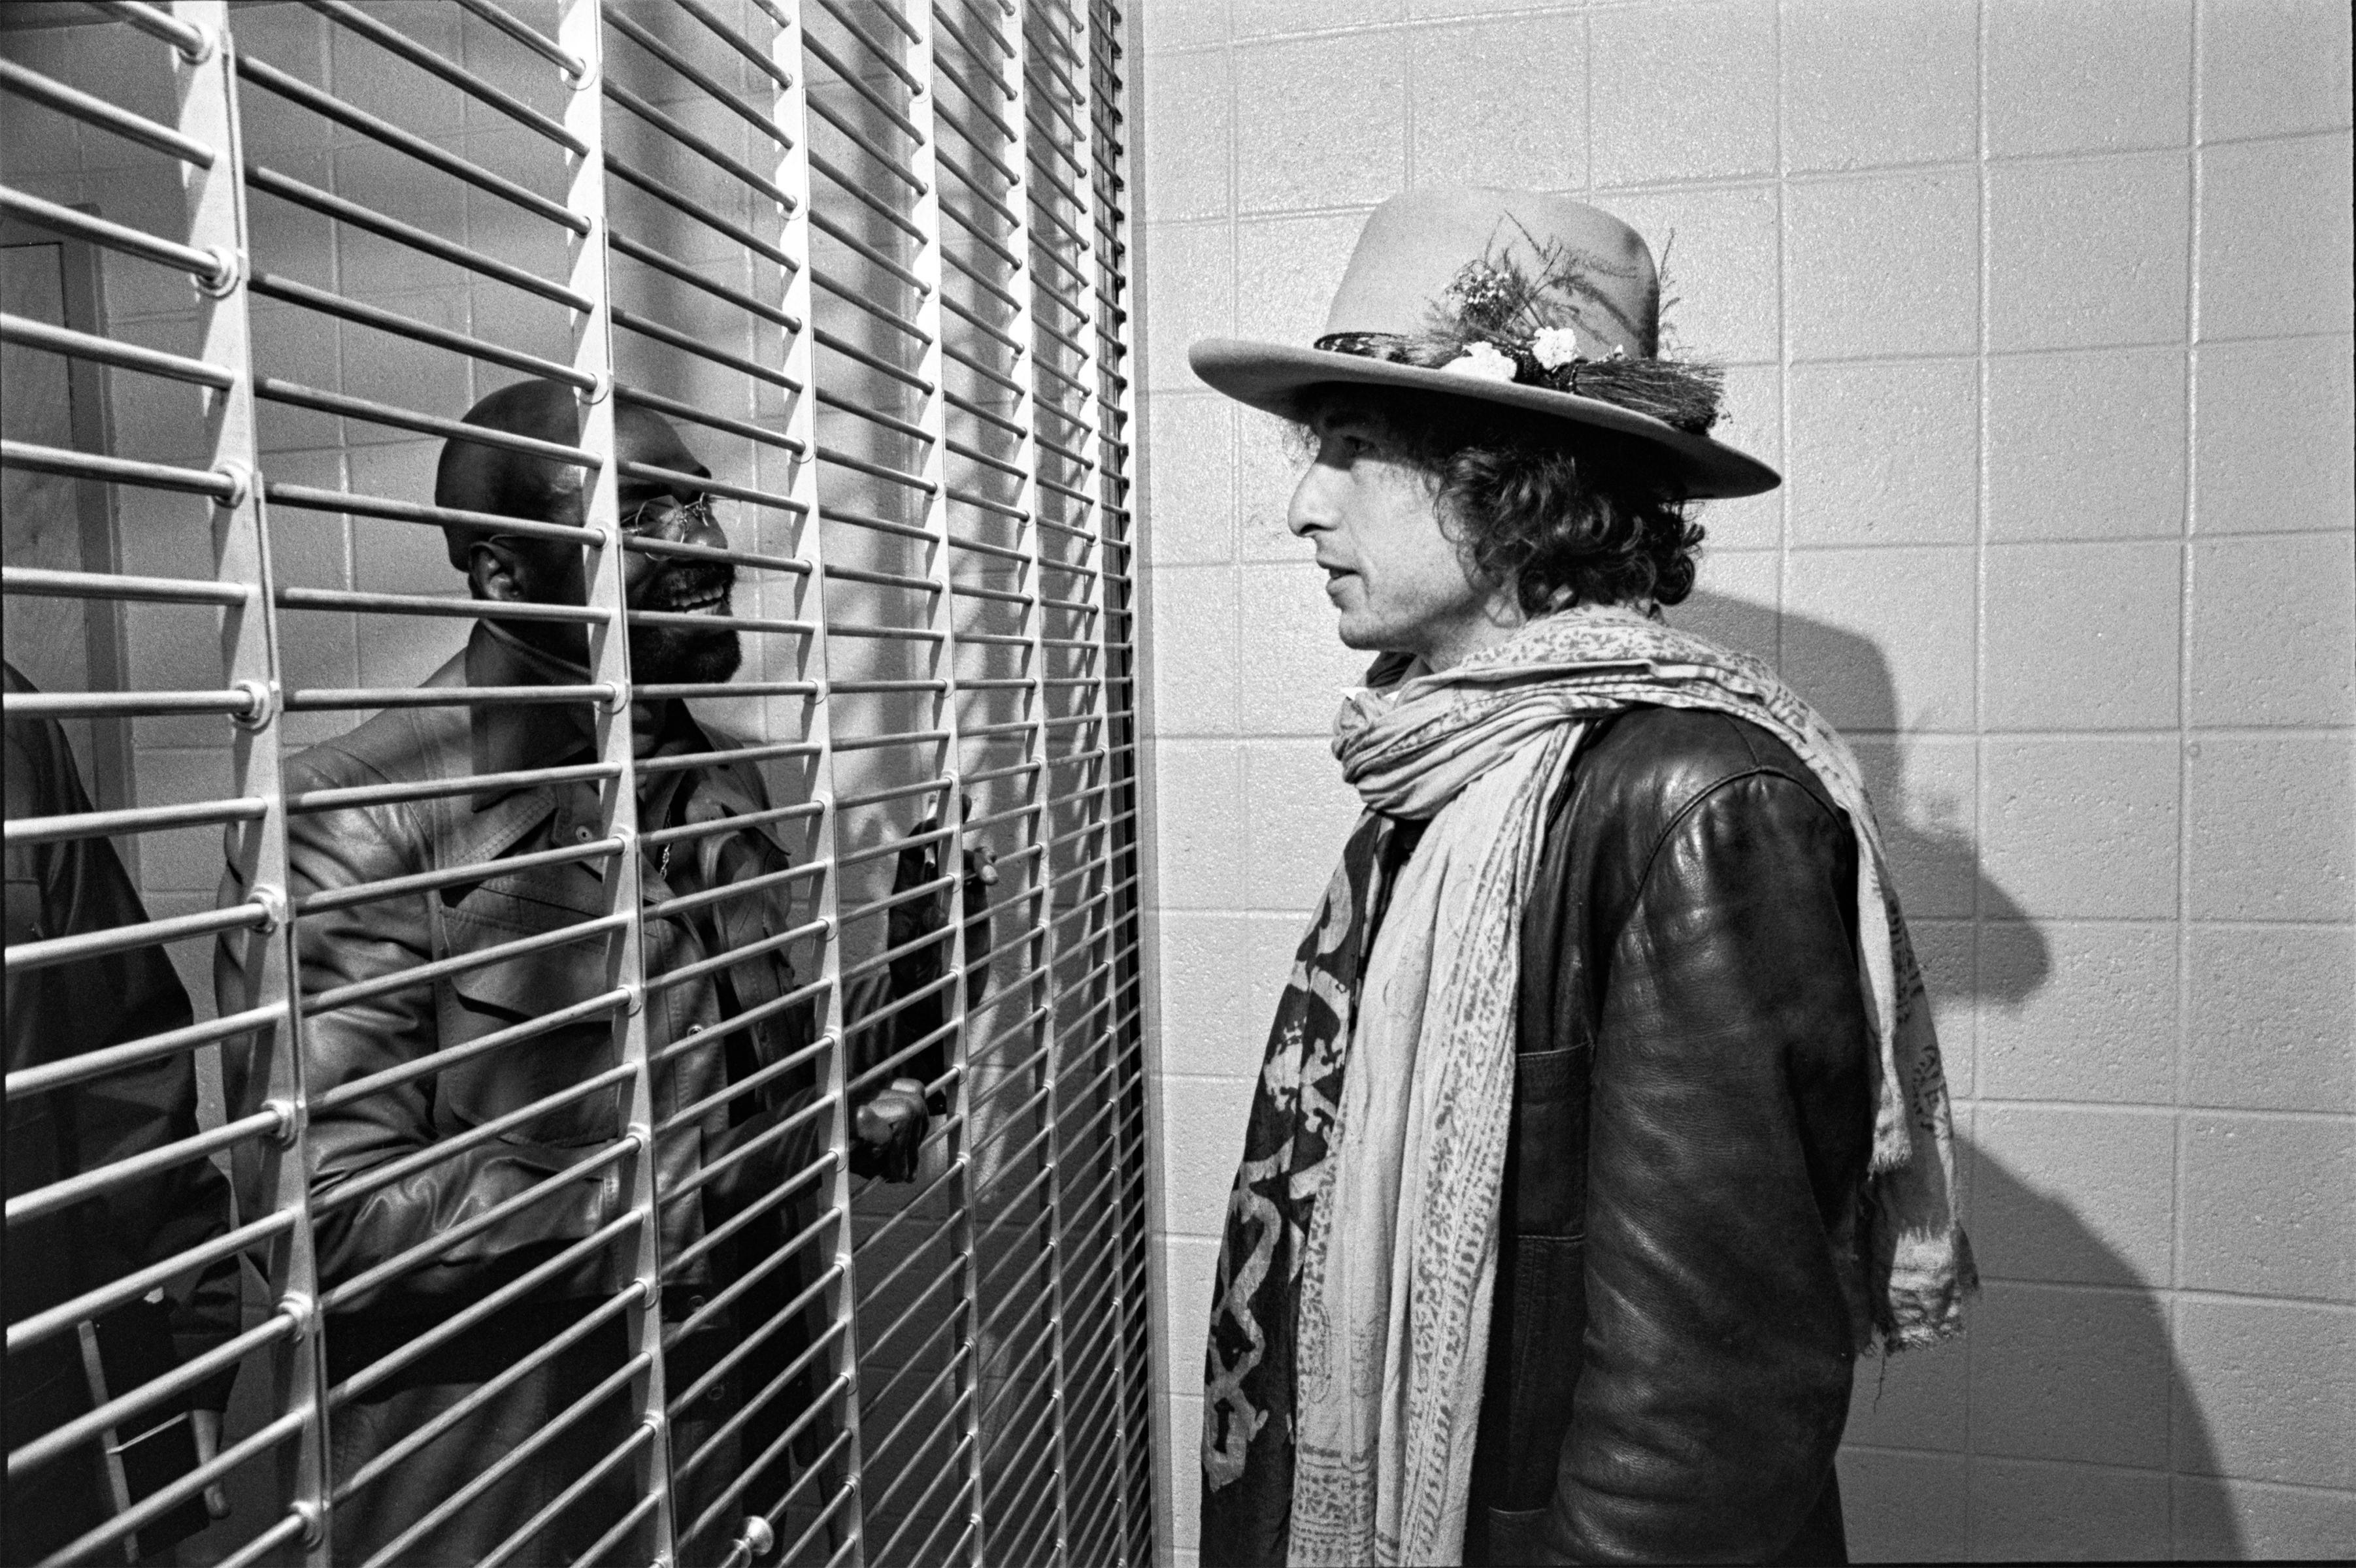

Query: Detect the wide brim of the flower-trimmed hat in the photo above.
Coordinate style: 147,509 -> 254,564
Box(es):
1187,336 -> 1784,502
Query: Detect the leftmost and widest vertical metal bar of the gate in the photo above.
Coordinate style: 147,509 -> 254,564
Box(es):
174,0 -> 327,1568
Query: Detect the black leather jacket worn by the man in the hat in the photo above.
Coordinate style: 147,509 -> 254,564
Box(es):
1465,709 -> 1870,1563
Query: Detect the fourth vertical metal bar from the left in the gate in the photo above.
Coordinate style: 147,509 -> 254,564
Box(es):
900,15 -> 985,1568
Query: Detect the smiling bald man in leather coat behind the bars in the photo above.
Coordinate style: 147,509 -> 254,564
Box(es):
222,382 -> 994,1563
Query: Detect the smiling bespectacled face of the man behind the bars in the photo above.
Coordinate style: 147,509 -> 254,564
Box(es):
480,410 -> 744,683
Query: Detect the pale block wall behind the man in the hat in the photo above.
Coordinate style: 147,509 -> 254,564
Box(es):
1140,0 -> 2356,1563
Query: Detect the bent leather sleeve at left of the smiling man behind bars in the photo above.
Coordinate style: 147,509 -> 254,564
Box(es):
235,781 -> 624,1311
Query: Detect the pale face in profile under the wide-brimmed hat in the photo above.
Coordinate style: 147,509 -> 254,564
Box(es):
1286,410 -> 1489,666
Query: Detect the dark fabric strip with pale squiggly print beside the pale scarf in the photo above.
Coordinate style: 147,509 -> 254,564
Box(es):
1202,812 -> 1402,1563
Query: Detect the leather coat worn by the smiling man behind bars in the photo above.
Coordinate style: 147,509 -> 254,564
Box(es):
222,624 -> 956,1563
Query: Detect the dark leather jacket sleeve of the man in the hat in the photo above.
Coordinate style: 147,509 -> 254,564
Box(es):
1543,772 -> 1870,1561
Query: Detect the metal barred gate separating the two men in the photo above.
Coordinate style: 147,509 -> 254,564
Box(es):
0,0 -> 1154,1565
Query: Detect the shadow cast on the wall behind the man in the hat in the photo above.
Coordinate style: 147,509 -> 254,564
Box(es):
1670,591 -> 2243,1561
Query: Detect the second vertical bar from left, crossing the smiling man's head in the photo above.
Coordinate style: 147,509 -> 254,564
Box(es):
556,0 -> 678,1563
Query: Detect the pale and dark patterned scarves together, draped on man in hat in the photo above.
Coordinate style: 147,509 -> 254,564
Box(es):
1202,608 -> 1977,1563
